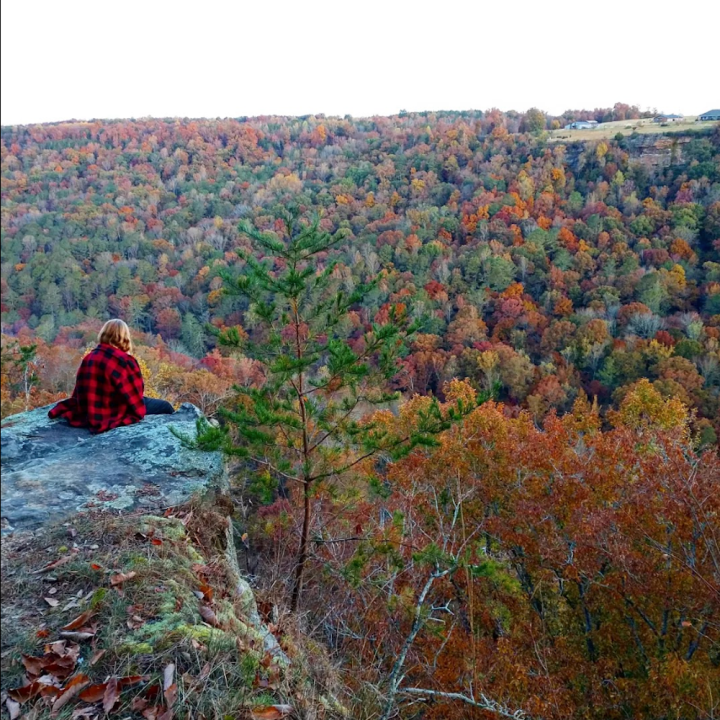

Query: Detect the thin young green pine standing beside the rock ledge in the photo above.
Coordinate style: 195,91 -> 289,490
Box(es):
188,212 -> 476,611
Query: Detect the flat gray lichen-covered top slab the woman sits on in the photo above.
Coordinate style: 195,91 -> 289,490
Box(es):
0,403 -> 226,534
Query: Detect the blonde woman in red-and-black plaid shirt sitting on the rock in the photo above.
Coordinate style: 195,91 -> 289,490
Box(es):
48,320 -> 174,433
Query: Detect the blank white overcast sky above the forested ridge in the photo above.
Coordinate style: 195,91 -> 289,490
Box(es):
0,0 -> 720,125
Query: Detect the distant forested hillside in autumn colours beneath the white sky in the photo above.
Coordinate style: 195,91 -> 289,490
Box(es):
2,106 -> 720,440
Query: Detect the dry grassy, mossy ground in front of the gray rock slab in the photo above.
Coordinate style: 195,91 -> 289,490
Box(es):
0,501 -> 348,720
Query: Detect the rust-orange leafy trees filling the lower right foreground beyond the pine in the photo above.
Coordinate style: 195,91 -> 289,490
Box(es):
300,381 -> 720,720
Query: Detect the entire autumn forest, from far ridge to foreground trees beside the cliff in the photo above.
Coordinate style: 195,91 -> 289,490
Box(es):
0,108 -> 720,720
